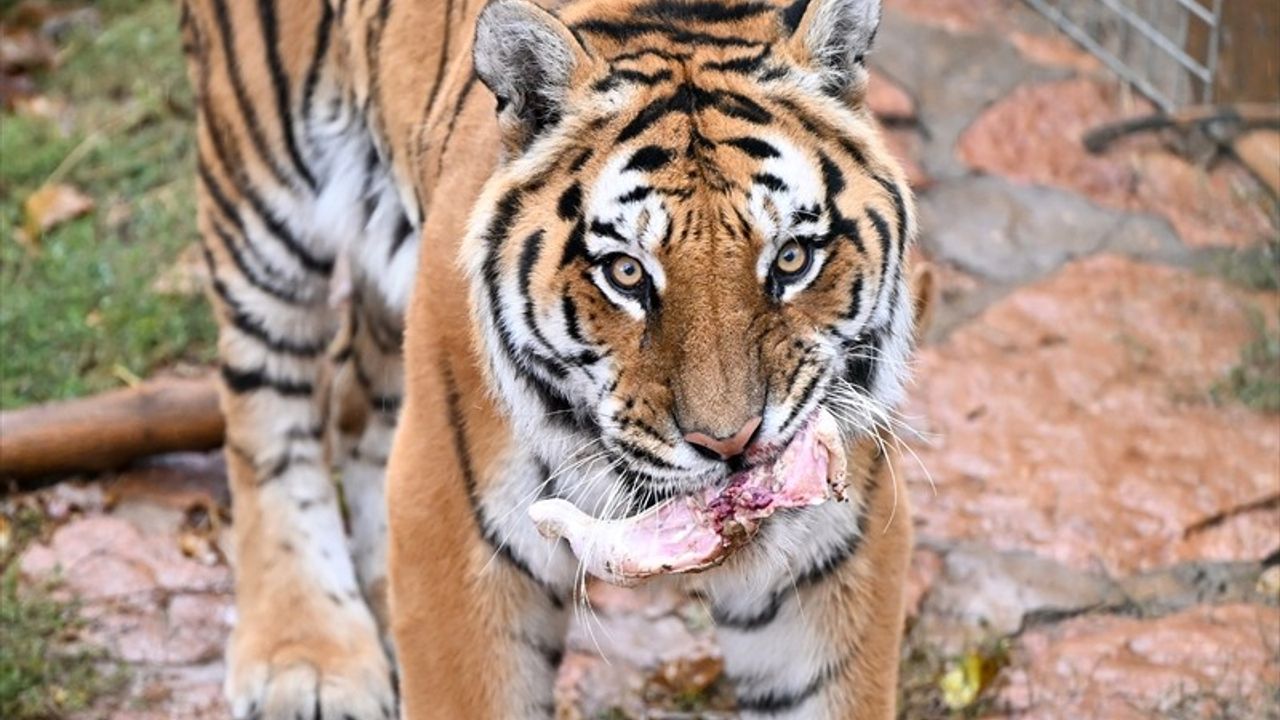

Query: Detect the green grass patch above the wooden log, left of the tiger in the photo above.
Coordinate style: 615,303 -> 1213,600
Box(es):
0,0 -> 215,407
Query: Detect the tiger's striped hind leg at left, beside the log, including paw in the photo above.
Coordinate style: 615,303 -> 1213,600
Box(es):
201,197 -> 396,720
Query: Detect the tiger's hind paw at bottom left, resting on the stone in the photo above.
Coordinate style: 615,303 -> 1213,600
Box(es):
225,609 -> 397,720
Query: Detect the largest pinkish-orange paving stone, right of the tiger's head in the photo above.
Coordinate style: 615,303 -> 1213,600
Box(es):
904,256 -> 1280,574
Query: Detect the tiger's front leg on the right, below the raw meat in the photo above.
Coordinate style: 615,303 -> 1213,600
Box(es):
696,448 -> 911,720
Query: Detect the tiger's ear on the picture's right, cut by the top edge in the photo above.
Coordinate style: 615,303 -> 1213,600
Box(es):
782,0 -> 881,96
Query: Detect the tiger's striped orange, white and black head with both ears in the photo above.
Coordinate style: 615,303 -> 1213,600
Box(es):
465,0 -> 913,507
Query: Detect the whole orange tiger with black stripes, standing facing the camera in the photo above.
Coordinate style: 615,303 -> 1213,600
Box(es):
180,0 -> 932,720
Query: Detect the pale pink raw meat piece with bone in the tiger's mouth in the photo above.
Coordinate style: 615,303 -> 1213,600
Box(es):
529,410 -> 846,587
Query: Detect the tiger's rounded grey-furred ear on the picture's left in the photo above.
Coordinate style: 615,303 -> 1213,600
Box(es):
472,0 -> 586,147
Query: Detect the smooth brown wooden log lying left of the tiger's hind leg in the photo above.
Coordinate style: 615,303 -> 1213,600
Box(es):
0,378 -> 223,479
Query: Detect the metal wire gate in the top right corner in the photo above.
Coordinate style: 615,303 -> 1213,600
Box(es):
1024,0 -> 1222,113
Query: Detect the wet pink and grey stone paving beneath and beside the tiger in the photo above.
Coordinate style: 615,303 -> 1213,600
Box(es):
10,0 -> 1280,719
